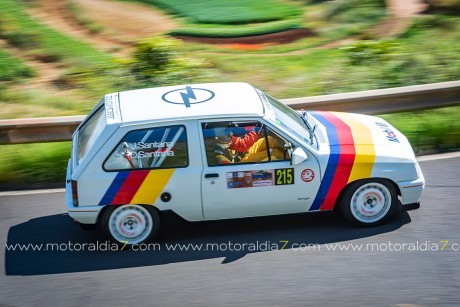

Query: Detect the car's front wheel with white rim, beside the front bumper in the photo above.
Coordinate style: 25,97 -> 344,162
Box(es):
340,179 -> 398,226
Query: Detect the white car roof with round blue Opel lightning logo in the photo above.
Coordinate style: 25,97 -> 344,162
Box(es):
105,82 -> 264,123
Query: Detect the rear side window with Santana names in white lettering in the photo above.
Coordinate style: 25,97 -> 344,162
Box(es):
104,126 -> 188,171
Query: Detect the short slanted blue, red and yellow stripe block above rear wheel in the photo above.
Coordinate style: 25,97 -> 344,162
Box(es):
99,169 -> 174,206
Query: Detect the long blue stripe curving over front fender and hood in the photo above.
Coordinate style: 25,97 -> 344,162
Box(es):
308,112 -> 340,211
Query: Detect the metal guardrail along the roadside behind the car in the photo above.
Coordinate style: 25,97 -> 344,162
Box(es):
0,81 -> 460,145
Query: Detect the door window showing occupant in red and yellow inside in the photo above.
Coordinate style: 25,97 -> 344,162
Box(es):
202,121 -> 290,166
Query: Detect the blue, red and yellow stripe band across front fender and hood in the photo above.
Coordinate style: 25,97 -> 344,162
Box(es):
309,112 -> 375,211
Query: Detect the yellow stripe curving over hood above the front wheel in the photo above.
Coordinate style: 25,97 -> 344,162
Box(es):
334,113 -> 375,183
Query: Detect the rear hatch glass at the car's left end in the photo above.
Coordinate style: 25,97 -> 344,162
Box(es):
77,107 -> 106,165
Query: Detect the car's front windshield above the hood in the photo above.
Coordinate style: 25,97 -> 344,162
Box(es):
264,93 -> 318,149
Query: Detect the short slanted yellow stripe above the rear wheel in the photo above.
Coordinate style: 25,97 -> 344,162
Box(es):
131,169 -> 174,205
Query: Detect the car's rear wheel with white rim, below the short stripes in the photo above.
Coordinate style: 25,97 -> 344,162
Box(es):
101,205 -> 160,246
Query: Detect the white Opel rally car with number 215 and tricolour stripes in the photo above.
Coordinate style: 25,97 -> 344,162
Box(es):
66,83 -> 425,244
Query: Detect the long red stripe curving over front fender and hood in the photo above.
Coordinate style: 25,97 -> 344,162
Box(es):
320,112 -> 356,210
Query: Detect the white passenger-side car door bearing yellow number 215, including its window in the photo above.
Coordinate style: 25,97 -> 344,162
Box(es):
200,120 -> 321,219
